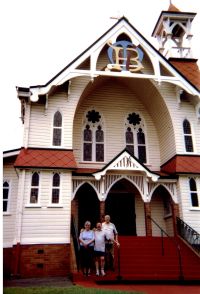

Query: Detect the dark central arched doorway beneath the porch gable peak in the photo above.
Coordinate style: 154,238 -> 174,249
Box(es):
105,179 -> 136,236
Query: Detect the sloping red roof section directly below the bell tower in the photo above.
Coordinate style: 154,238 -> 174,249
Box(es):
169,58 -> 200,89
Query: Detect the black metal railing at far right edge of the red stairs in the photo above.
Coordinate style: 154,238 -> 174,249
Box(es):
176,217 -> 200,254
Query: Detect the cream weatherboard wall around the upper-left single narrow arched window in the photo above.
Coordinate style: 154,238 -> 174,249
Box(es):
28,77 -> 89,149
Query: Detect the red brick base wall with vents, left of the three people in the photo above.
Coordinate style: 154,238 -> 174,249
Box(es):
5,244 -> 70,278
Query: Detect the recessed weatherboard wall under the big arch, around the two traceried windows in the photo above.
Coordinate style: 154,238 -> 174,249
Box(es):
73,79 -> 160,170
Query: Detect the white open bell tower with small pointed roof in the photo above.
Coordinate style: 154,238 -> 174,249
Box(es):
152,1 -> 196,58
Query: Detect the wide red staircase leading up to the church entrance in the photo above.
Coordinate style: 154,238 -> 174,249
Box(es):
73,236 -> 200,283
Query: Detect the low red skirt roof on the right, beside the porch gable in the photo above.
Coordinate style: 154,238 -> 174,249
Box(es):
161,155 -> 200,174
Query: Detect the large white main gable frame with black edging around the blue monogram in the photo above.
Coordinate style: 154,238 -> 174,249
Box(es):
18,16 -> 200,102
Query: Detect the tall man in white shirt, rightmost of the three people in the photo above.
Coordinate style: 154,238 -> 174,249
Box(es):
102,215 -> 120,269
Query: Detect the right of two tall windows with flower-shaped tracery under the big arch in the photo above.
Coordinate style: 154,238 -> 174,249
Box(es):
125,113 -> 147,163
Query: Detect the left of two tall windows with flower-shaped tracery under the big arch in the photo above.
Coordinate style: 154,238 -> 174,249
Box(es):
83,110 -> 104,162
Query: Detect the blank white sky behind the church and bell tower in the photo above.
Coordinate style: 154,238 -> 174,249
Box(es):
0,0 -> 200,151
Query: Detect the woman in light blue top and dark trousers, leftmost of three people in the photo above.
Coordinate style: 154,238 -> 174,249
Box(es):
79,221 -> 94,276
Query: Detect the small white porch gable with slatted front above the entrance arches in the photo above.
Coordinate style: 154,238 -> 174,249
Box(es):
93,148 -> 159,182
